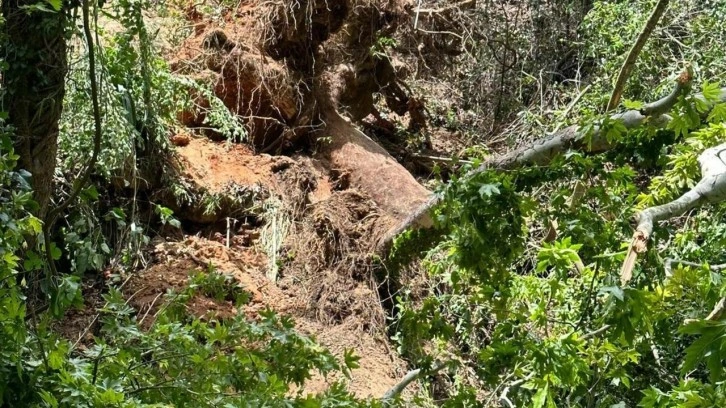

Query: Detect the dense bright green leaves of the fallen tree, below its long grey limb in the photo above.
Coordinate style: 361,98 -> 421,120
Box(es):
393,67 -> 726,407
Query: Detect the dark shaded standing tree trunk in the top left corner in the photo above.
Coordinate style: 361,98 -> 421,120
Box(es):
2,0 -> 67,219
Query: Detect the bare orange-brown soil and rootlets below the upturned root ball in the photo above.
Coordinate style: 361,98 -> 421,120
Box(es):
145,137 -> 406,397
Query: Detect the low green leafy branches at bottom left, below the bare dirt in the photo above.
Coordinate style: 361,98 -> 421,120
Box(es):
0,278 -> 375,407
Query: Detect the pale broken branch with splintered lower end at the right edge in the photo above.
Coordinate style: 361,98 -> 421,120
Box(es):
620,143 -> 726,285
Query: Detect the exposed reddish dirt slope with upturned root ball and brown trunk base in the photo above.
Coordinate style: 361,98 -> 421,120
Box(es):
58,0 -> 444,397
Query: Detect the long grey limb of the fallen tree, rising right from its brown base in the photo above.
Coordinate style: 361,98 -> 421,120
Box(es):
378,70 -> 712,254
